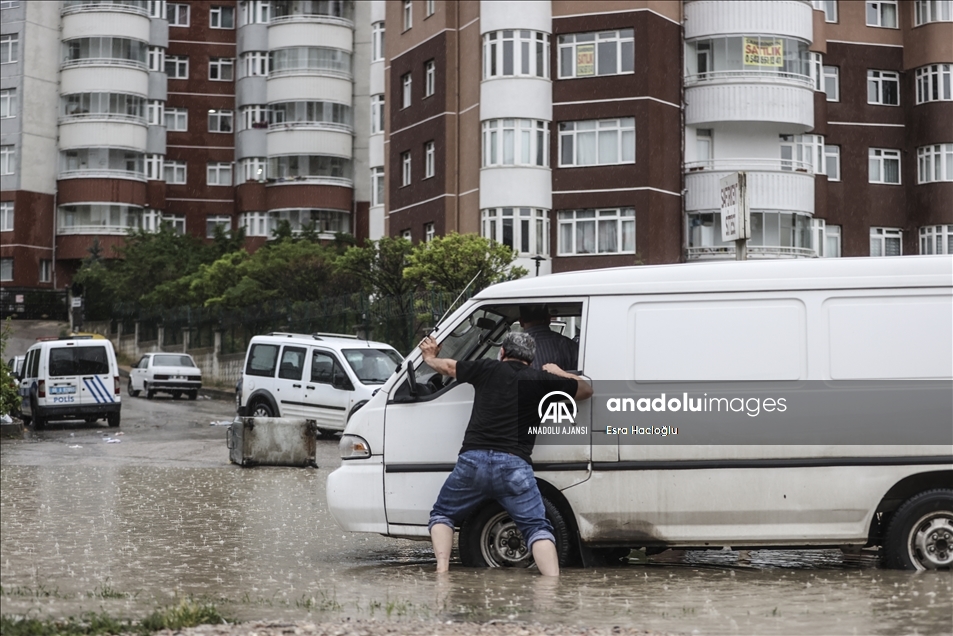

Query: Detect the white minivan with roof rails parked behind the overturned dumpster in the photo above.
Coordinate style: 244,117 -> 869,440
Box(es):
235,333 -> 403,435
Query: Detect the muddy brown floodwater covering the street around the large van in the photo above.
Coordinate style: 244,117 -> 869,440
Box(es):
0,457 -> 953,634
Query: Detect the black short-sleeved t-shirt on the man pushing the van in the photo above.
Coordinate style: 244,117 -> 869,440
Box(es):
457,360 -> 577,463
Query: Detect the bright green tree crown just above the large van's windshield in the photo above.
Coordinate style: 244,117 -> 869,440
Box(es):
404,232 -> 528,293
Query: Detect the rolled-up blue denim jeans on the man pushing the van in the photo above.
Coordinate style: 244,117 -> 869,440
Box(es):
428,450 -> 556,547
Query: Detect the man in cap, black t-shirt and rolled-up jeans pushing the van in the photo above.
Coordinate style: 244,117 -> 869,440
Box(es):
420,332 -> 592,576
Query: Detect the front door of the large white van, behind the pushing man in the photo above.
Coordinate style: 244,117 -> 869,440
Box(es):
384,299 -> 590,532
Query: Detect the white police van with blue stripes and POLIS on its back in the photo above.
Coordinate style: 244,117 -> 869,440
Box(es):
20,336 -> 122,430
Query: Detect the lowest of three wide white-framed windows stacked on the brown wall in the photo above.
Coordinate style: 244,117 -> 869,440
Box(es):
558,208 -> 635,256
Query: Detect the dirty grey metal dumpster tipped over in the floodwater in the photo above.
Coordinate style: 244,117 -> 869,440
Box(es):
225,417 -> 318,468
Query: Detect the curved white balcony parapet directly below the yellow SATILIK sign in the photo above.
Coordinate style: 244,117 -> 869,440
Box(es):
685,70 -> 814,133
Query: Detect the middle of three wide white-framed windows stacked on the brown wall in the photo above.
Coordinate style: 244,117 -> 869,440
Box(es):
559,117 -> 635,167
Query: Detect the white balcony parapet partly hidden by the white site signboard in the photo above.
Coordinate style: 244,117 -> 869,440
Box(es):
685,158 -> 814,214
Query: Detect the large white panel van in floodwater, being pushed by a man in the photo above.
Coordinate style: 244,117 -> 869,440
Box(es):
327,256 -> 953,569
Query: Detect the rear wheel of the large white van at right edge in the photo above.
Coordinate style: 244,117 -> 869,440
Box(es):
884,488 -> 953,570
